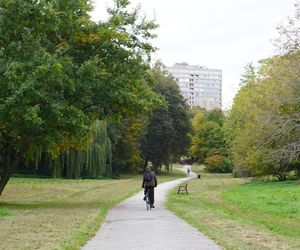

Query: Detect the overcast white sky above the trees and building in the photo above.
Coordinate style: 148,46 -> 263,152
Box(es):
92,0 -> 296,108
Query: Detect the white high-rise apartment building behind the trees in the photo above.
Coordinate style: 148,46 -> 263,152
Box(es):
166,63 -> 222,110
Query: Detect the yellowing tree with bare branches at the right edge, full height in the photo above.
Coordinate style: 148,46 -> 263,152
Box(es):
264,2 -> 300,178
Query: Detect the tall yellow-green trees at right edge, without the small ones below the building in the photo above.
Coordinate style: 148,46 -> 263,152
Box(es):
224,5 -> 300,180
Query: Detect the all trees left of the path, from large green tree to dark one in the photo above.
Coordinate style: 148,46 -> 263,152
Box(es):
0,0 -> 190,195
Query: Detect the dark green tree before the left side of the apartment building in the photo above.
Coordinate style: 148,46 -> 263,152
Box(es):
142,63 -> 191,169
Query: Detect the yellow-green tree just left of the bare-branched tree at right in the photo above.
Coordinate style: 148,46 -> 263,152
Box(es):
224,70 -> 261,176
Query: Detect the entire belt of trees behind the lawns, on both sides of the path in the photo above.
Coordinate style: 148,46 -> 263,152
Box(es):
0,0 -> 300,195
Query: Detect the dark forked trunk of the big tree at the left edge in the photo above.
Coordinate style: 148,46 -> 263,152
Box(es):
0,152 -> 21,197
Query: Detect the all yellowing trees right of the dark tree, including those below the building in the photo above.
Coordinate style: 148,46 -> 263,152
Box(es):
191,4 -> 300,180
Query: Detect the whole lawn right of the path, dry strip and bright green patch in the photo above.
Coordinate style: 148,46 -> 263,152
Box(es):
167,166 -> 300,249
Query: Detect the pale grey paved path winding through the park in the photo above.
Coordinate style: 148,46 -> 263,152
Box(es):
82,166 -> 220,250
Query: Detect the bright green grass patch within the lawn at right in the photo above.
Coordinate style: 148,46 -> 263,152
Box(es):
223,181 -> 300,236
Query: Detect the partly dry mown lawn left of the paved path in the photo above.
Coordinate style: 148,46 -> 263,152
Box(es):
0,170 -> 185,250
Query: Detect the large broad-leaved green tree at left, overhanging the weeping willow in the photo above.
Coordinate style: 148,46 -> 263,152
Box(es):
0,0 -> 156,195
